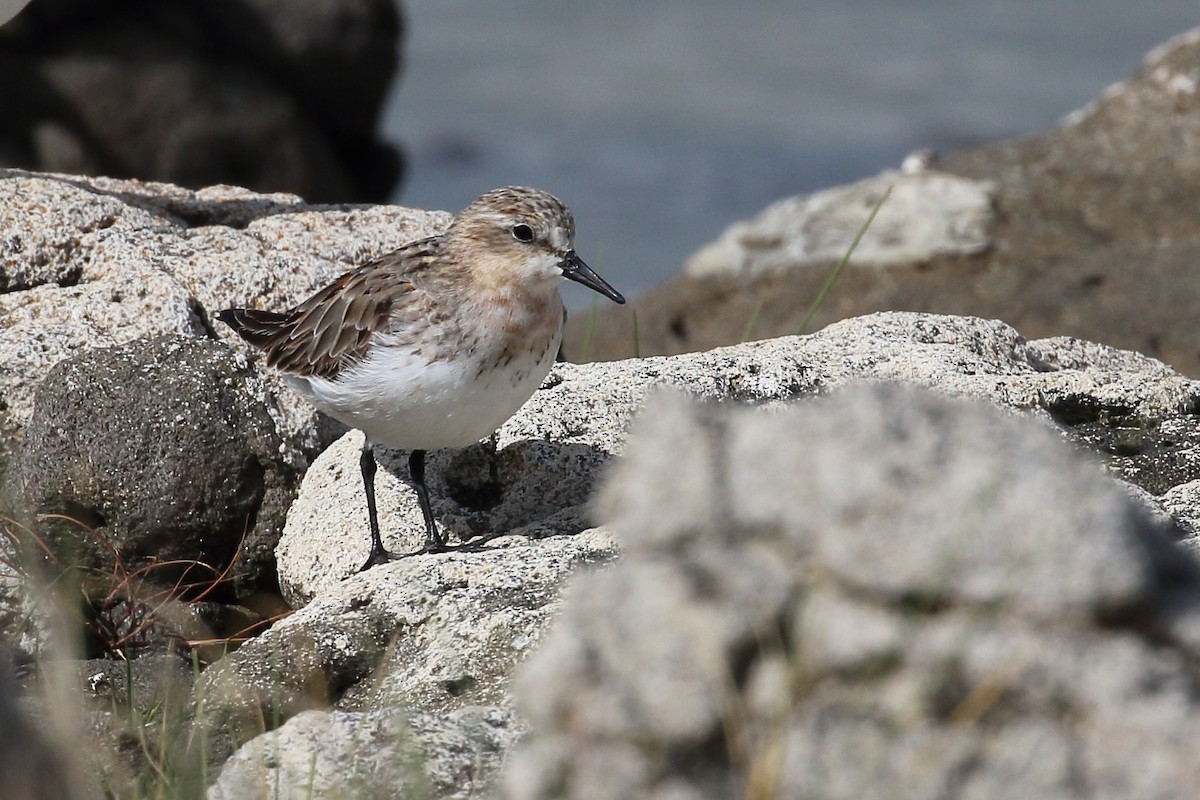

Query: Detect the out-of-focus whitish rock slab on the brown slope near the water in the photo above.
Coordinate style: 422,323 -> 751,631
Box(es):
684,170 -> 992,277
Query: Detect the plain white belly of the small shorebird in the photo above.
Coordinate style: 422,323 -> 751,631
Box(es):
290,336 -> 560,450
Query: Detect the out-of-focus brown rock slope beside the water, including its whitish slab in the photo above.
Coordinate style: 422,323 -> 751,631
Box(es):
569,29 -> 1200,375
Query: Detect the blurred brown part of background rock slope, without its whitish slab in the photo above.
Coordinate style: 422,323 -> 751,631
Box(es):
565,30 -> 1200,375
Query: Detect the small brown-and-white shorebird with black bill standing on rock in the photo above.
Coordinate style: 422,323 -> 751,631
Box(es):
217,186 -> 625,570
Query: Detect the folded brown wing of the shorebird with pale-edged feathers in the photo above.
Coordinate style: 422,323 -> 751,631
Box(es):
218,237 -> 440,378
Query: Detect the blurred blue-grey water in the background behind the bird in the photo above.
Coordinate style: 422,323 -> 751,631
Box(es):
383,0 -> 1200,307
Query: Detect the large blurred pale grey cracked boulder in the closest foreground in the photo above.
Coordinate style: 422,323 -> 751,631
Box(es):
505,386 -> 1200,800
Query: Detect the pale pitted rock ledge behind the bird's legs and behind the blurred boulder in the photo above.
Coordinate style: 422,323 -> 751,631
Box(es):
277,313 -> 1200,604
